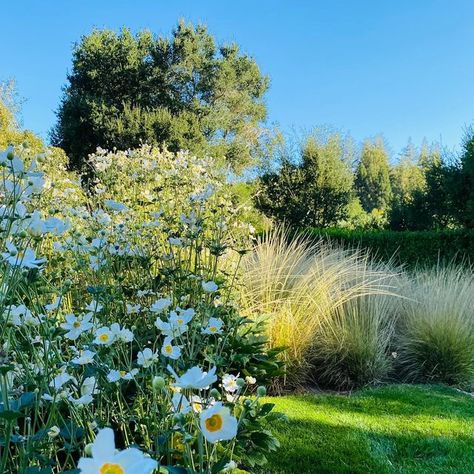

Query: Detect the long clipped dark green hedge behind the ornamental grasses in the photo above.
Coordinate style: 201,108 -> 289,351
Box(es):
307,229 -> 474,267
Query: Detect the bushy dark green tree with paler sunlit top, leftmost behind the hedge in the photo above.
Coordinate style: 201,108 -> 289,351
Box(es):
255,134 -> 353,226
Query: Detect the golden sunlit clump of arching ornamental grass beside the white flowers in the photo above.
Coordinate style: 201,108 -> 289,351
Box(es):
242,228 -> 392,386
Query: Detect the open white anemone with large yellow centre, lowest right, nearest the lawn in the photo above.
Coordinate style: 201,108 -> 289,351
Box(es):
199,402 -> 237,443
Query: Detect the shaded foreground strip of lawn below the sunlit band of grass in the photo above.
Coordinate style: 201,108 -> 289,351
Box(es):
258,420 -> 474,474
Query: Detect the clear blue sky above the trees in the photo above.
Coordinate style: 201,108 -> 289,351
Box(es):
0,0 -> 474,157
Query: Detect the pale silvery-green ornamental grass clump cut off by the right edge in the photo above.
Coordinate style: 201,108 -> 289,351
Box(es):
399,266 -> 474,388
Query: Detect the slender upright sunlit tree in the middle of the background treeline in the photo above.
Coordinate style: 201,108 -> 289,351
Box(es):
355,139 -> 392,212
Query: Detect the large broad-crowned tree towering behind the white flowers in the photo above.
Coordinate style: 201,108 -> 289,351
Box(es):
51,21 -> 269,169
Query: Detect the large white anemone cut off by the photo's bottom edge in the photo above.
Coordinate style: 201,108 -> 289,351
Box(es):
77,428 -> 158,474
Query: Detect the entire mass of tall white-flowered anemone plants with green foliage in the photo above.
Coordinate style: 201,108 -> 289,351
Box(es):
0,147 -> 279,474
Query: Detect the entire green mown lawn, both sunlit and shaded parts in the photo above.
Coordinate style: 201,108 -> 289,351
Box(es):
257,385 -> 474,474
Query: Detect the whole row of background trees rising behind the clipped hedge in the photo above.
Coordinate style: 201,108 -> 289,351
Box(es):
255,130 -> 474,230
